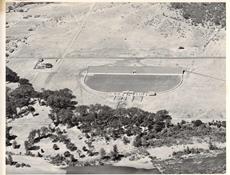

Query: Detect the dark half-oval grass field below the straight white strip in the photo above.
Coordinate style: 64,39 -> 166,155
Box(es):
85,74 -> 181,92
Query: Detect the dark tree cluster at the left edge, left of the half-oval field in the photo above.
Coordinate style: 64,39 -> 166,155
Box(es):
6,67 -> 77,120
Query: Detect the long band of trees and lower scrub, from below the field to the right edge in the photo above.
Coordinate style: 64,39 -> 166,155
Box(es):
45,101 -> 225,147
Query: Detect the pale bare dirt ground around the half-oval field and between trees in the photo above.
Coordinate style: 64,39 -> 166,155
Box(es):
6,3 -> 226,173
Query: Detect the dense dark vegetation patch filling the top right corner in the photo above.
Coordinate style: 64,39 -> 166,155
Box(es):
171,2 -> 226,27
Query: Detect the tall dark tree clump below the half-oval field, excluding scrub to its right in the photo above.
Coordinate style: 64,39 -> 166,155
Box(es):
47,104 -> 171,142
